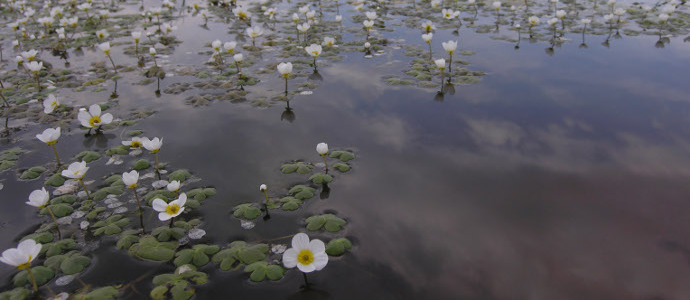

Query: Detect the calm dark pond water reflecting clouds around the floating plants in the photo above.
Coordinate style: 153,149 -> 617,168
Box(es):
0,2 -> 690,300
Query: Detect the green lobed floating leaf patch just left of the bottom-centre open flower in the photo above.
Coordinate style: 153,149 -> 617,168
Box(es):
212,241 -> 268,271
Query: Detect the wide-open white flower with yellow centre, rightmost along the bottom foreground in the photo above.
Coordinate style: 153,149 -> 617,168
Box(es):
283,233 -> 328,273
